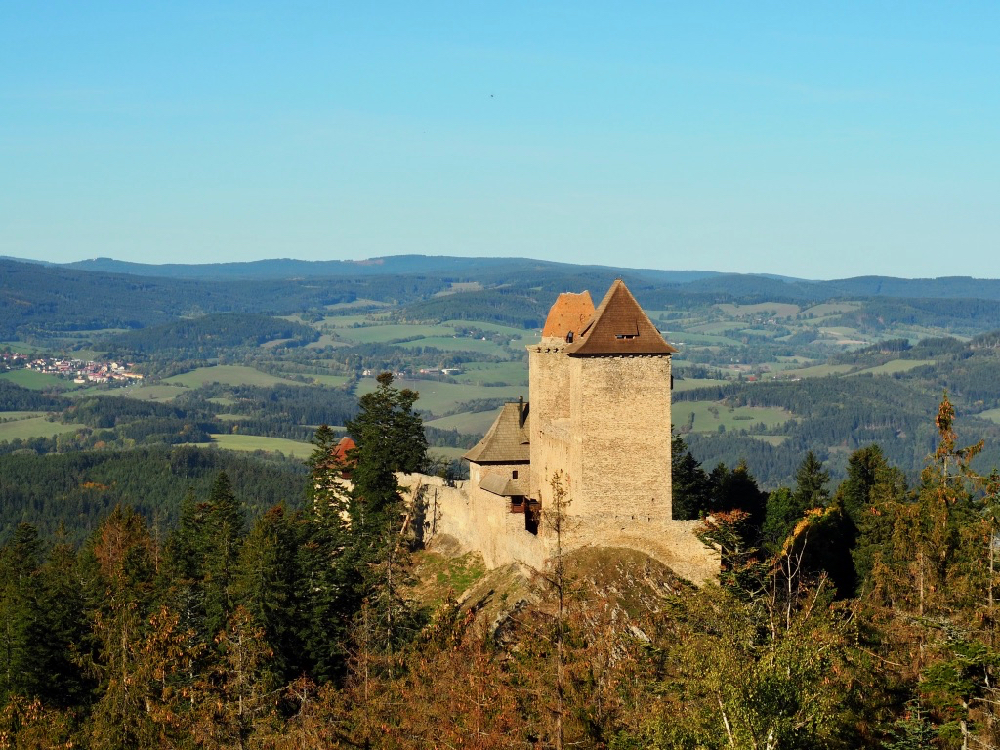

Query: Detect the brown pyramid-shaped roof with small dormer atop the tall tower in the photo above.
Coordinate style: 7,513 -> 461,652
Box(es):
564,279 -> 677,356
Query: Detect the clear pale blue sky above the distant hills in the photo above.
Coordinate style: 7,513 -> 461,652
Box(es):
0,0 -> 1000,278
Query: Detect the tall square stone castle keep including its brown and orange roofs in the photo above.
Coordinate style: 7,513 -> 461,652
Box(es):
528,279 -> 676,536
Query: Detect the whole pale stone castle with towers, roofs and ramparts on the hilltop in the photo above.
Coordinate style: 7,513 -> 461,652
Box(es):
406,279 -> 719,583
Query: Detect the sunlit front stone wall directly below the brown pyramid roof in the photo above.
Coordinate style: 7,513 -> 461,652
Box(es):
568,356 -> 672,526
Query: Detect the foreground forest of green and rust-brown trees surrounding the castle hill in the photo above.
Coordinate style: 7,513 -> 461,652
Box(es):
0,373 -> 1000,749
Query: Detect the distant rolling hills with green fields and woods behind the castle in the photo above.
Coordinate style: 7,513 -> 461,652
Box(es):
0,250 -> 1000,486
